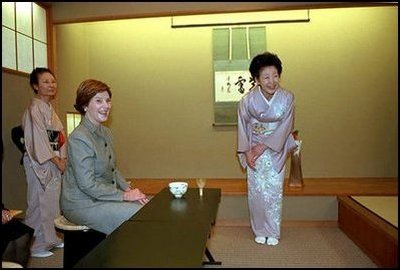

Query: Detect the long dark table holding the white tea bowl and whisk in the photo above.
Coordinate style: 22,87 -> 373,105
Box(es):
75,188 -> 221,268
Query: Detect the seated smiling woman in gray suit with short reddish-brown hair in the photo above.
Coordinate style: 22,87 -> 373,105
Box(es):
61,79 -> 148,235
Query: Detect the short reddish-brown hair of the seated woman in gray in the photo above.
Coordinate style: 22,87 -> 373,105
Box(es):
74,79 -> 111,115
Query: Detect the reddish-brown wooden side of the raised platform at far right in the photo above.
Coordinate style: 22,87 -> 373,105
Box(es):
338,196 -> 398,268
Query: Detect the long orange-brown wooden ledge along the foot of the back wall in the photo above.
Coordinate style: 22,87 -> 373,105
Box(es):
128,178 -> 398,196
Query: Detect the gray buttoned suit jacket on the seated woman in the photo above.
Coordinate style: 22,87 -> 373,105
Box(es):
61,117 -> 129,210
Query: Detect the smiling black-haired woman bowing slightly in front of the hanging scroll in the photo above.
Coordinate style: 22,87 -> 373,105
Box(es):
237,52 -> 295,245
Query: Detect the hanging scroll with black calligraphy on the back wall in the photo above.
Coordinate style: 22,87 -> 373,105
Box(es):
213,26 -> 266,125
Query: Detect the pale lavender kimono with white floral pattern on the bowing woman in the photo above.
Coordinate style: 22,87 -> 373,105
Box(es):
237,87 -> 296,239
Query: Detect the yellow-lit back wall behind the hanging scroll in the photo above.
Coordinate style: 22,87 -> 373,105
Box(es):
55,7 -> 398,178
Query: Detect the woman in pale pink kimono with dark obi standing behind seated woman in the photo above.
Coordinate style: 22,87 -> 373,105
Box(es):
22,68 -> 66,257
